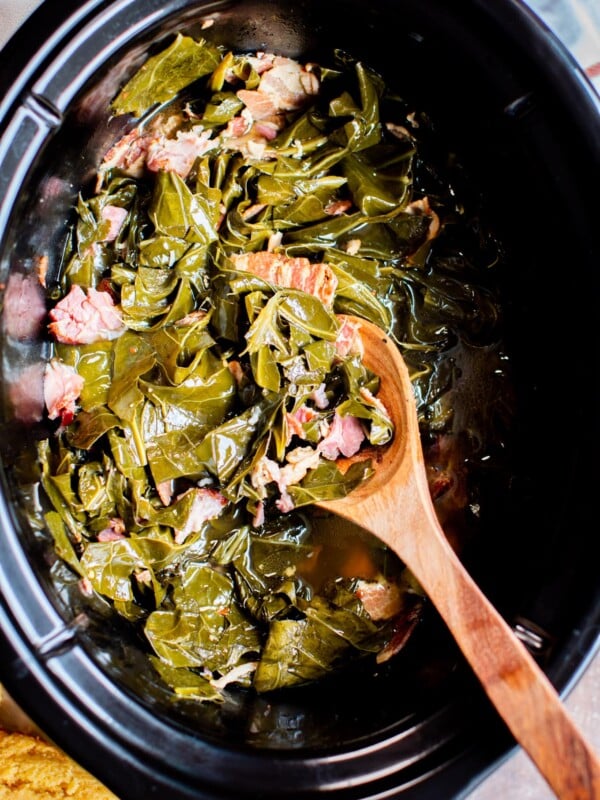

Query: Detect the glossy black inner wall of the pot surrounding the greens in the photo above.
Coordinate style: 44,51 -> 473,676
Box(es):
3,0 -> 597,796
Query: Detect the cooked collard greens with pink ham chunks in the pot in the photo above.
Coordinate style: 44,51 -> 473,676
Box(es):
21,34 -> 508,702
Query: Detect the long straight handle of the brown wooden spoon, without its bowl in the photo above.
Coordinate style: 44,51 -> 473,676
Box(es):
408,510 -> 600,800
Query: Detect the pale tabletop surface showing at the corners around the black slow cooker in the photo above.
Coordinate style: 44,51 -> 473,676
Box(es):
0,0 -> 600,800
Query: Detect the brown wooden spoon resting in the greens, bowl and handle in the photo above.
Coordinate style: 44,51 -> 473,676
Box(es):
319,317 -> 600,800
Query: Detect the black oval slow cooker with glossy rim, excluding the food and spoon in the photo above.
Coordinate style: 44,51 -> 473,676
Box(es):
0,0 -> 600,800
